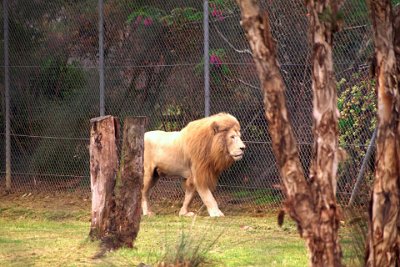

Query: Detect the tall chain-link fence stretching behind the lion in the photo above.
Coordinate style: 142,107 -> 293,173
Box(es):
0,0 -> 382,214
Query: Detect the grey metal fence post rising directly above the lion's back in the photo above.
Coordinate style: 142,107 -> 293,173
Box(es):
203,0 -> 210,117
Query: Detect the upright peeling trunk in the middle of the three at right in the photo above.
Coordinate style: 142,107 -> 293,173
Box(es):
306,0 -> 342,266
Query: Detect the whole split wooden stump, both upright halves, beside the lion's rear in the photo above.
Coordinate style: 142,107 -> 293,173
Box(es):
89,116 -> 148,251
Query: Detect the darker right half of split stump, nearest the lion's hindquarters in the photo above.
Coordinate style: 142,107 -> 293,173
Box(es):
114,117 -> 148,247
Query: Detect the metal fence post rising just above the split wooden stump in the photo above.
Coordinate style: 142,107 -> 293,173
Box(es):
99,0 -> 105,116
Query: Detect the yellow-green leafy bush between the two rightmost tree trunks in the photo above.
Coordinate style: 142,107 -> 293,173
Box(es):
337,74 -> 377,160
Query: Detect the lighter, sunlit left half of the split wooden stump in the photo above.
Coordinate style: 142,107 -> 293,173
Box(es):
89,116 -> 119,240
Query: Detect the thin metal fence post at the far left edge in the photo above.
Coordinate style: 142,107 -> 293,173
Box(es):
3,0 -> 11,191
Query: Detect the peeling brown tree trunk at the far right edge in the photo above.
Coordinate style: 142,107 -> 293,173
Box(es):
366,0 -> 400,266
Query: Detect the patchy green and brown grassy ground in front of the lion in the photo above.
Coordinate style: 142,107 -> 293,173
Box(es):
0,196 -> 360,266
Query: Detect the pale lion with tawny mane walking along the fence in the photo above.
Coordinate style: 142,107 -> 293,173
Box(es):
142,113 -> 245,217
